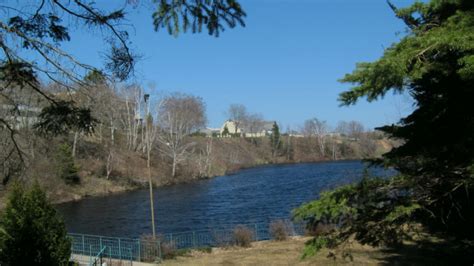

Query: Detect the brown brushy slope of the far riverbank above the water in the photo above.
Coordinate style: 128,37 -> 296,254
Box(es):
0,137 -> 393,208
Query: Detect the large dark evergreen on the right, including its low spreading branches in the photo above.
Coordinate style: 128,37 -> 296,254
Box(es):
296,0 -> 474,258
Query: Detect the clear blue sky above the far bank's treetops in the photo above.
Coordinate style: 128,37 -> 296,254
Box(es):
62,0 -> 412,128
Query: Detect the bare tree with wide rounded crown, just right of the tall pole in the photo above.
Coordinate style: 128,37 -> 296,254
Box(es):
158,93 -> 206,178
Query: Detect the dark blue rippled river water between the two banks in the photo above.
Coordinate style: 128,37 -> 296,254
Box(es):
57,161 -> 394,237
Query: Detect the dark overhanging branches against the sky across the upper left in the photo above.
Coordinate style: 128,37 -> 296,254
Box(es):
0,0 -> 246,179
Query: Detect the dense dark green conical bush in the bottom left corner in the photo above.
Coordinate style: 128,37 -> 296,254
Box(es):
0,184 -> 71,266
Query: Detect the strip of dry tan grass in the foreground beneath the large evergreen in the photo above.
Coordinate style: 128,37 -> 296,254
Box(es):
163,236 -> 468,266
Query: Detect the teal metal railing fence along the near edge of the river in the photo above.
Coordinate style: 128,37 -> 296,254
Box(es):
69,221 -> 305,262
